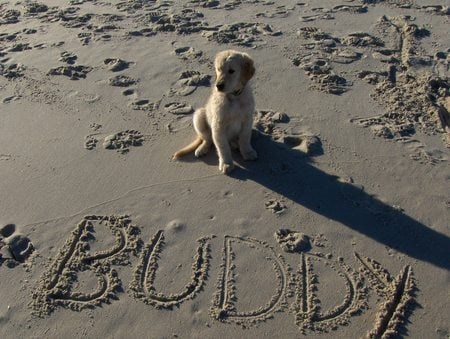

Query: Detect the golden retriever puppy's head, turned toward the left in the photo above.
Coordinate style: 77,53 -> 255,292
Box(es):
214,50 -> 255,93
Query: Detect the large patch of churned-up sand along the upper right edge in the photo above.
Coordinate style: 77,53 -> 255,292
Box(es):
351,16 -> 450,149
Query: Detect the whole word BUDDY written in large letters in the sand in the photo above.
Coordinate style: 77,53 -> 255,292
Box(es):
30,215 -> 416,338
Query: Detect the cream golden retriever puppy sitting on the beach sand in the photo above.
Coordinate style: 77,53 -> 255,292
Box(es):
173,50 -> 257,174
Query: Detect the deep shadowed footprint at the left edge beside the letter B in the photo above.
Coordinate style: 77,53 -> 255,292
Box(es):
0,224 -> 34,268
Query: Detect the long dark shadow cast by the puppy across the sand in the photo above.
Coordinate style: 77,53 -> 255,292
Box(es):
197,133 -> 450,269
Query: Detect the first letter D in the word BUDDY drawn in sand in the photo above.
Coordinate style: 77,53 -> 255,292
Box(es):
210,235 -> 290,326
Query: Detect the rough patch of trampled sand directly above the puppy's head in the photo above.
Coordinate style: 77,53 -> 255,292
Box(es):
202,22 -> 282,47
